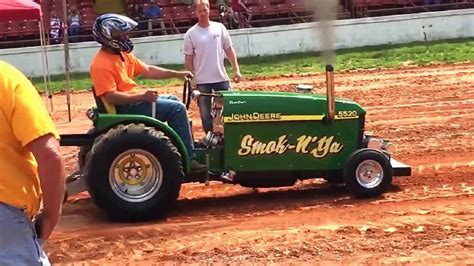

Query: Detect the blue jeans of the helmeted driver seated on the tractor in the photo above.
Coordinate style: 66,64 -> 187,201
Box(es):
115,95 -> 196,159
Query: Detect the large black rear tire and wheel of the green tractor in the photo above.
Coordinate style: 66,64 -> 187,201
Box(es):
87,124 -> 184,222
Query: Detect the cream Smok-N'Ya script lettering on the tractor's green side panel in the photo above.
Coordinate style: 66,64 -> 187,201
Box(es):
237,135 -> 344,159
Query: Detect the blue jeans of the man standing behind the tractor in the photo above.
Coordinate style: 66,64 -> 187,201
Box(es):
196,81 -> 231,133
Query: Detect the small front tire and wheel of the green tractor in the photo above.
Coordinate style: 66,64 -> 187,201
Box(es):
344,149 -> 393,198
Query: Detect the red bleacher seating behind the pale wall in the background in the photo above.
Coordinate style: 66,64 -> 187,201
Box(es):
0,0 -> 474,48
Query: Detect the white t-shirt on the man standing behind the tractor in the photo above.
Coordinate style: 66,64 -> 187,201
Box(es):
183,21 -> 232,84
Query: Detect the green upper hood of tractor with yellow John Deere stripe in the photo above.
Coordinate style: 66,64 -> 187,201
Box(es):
221,91 -> 365,120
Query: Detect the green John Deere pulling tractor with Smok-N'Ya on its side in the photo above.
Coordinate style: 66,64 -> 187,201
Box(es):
61,65 -> 411,221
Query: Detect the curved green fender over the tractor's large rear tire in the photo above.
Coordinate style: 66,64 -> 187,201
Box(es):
94,113 -> 190,174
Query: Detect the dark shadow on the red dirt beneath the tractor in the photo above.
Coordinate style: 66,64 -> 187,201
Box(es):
59,183 -> 401,224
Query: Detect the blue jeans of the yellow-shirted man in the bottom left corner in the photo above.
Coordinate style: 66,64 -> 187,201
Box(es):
0,203 -> 51,266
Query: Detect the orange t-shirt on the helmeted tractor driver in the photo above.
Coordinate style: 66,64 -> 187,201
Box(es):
90,49 -> 145,96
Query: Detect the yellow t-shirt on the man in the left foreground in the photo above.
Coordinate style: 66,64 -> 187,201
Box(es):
0,61 -> 59,217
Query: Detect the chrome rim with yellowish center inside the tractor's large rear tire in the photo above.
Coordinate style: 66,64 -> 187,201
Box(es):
109,149 -> 163,202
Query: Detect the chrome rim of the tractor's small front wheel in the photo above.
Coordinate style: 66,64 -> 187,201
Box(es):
356,160 -> 384,188
